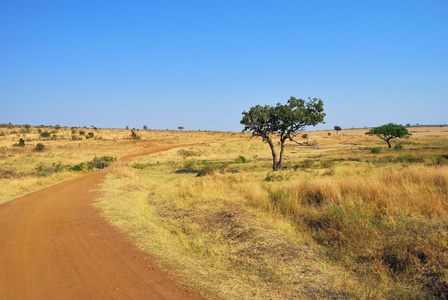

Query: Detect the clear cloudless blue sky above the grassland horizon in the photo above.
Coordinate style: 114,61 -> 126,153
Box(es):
0,0 -> 448,131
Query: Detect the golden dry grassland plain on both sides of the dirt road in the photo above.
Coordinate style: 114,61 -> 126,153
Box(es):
0,124 -> 448,299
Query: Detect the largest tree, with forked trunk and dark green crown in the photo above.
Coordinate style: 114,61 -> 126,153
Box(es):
240,97 -> 325,171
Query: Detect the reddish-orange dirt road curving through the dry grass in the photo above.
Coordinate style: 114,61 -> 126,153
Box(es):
0,147 -> 203,299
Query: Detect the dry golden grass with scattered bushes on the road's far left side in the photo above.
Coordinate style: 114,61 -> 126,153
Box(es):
0,124 -> 241,204
